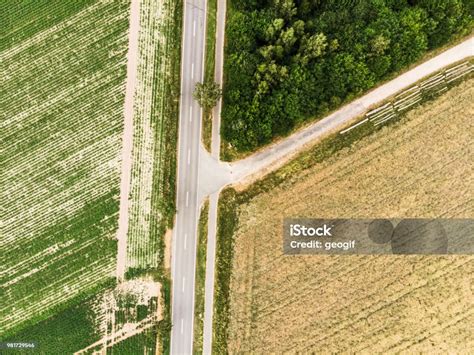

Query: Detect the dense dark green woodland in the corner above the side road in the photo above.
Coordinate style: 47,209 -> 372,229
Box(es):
222,0 -> 473,151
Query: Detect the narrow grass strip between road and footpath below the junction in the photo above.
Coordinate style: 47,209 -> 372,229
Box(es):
193,200 -> 209,354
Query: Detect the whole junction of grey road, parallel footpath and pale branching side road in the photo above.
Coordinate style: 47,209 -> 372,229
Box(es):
171,0 -> 474,354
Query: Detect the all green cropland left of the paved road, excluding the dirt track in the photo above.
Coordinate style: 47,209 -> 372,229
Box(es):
0,0 -> 182,354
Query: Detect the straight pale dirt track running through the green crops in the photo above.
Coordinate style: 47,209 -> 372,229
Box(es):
117,0 -> 140,280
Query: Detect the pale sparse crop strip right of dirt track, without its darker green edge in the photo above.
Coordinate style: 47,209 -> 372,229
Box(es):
127,2 -> 165,267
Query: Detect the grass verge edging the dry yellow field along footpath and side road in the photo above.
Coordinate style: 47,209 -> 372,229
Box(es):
213,74 -> 473,354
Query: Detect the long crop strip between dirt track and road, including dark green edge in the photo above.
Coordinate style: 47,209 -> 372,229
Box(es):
127,0 -> 179,269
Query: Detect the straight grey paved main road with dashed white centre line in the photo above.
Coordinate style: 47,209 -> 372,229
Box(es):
171,0 -> 206,354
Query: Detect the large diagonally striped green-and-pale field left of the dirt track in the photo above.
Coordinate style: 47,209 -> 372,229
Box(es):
0,1 -> 129,335
